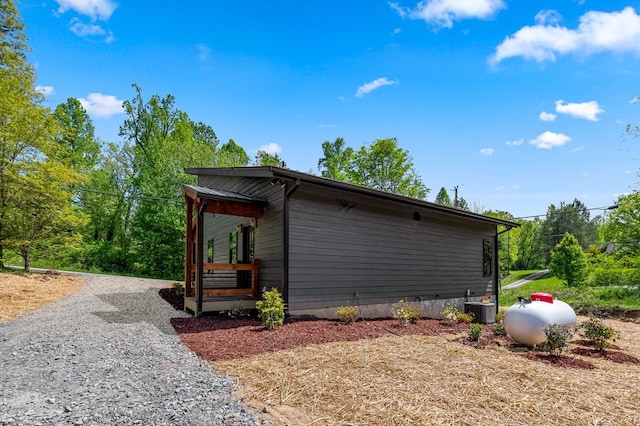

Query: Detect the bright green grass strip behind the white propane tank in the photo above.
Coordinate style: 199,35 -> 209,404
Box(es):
500,271 -> 640,315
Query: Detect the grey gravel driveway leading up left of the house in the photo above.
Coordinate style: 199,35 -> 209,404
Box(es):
0,274 -> 261,425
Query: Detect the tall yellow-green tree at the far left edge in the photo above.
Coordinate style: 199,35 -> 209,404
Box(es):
0,0 -> 78,268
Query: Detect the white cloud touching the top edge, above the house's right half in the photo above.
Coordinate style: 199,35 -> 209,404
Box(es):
389,0 -> 505,28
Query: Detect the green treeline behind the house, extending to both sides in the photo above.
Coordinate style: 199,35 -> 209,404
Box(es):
0,0 -> 640,284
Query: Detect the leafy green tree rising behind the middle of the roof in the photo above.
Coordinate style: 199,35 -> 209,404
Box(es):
318,138 -> 430,199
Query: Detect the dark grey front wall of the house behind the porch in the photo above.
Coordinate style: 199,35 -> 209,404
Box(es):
198,176 -> 284,292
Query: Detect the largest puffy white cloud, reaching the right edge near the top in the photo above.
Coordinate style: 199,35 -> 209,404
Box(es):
489,7 -> 640,65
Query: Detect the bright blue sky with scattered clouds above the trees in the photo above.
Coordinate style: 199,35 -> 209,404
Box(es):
18,0 -> 640,217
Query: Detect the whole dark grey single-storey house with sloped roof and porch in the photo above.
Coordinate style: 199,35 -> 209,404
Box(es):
183,167 -> 518,318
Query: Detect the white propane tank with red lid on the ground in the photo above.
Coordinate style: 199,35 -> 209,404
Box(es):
503,293 -> 576,346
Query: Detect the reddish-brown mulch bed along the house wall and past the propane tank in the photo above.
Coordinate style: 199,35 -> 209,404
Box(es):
160,288 -> 640,369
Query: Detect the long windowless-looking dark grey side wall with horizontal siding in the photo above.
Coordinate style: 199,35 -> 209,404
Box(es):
288,184 -> 495,316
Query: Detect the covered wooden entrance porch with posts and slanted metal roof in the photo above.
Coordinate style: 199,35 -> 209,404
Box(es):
183,185 -> 267,317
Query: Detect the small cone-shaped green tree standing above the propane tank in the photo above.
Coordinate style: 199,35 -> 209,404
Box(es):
550,232 -> 587,287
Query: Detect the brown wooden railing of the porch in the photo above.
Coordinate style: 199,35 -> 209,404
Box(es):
185,259 -> 260,299
